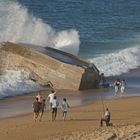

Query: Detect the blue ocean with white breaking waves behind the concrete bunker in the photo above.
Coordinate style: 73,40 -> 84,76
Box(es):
0,0 -> 140,98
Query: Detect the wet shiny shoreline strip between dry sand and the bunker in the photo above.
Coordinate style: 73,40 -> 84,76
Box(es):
0,67 -> 140,118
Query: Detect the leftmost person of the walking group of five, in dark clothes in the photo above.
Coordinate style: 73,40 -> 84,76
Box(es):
32,98 -> 40,122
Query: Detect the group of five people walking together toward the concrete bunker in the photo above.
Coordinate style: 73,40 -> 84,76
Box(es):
32,90 -> 69,121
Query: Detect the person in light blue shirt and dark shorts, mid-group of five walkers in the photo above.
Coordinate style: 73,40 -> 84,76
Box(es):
52,96 -> 59,121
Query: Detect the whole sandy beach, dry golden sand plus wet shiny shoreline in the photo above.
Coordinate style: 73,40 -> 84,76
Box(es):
0,69 -> 140,140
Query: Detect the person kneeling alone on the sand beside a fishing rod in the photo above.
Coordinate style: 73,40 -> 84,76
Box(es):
100,108 -> 111,127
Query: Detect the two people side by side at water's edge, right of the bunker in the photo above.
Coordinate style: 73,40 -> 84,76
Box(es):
114,79 -> 127,96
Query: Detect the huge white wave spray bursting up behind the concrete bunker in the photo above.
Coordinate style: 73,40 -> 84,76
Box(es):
0,0 -> 80,54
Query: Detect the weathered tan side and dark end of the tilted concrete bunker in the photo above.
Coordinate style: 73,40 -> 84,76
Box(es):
0,42 -> 99,90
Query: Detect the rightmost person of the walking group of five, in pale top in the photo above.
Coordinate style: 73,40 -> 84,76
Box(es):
61,98 -> 69,121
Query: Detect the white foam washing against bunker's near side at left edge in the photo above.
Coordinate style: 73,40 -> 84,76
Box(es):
0,70 -> 41,99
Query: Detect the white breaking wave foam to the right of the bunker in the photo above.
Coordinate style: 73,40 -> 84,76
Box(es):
89,46 -> 140,76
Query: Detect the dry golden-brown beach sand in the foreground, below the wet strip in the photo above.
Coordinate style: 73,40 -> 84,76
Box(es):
0,97 -> 140,140
